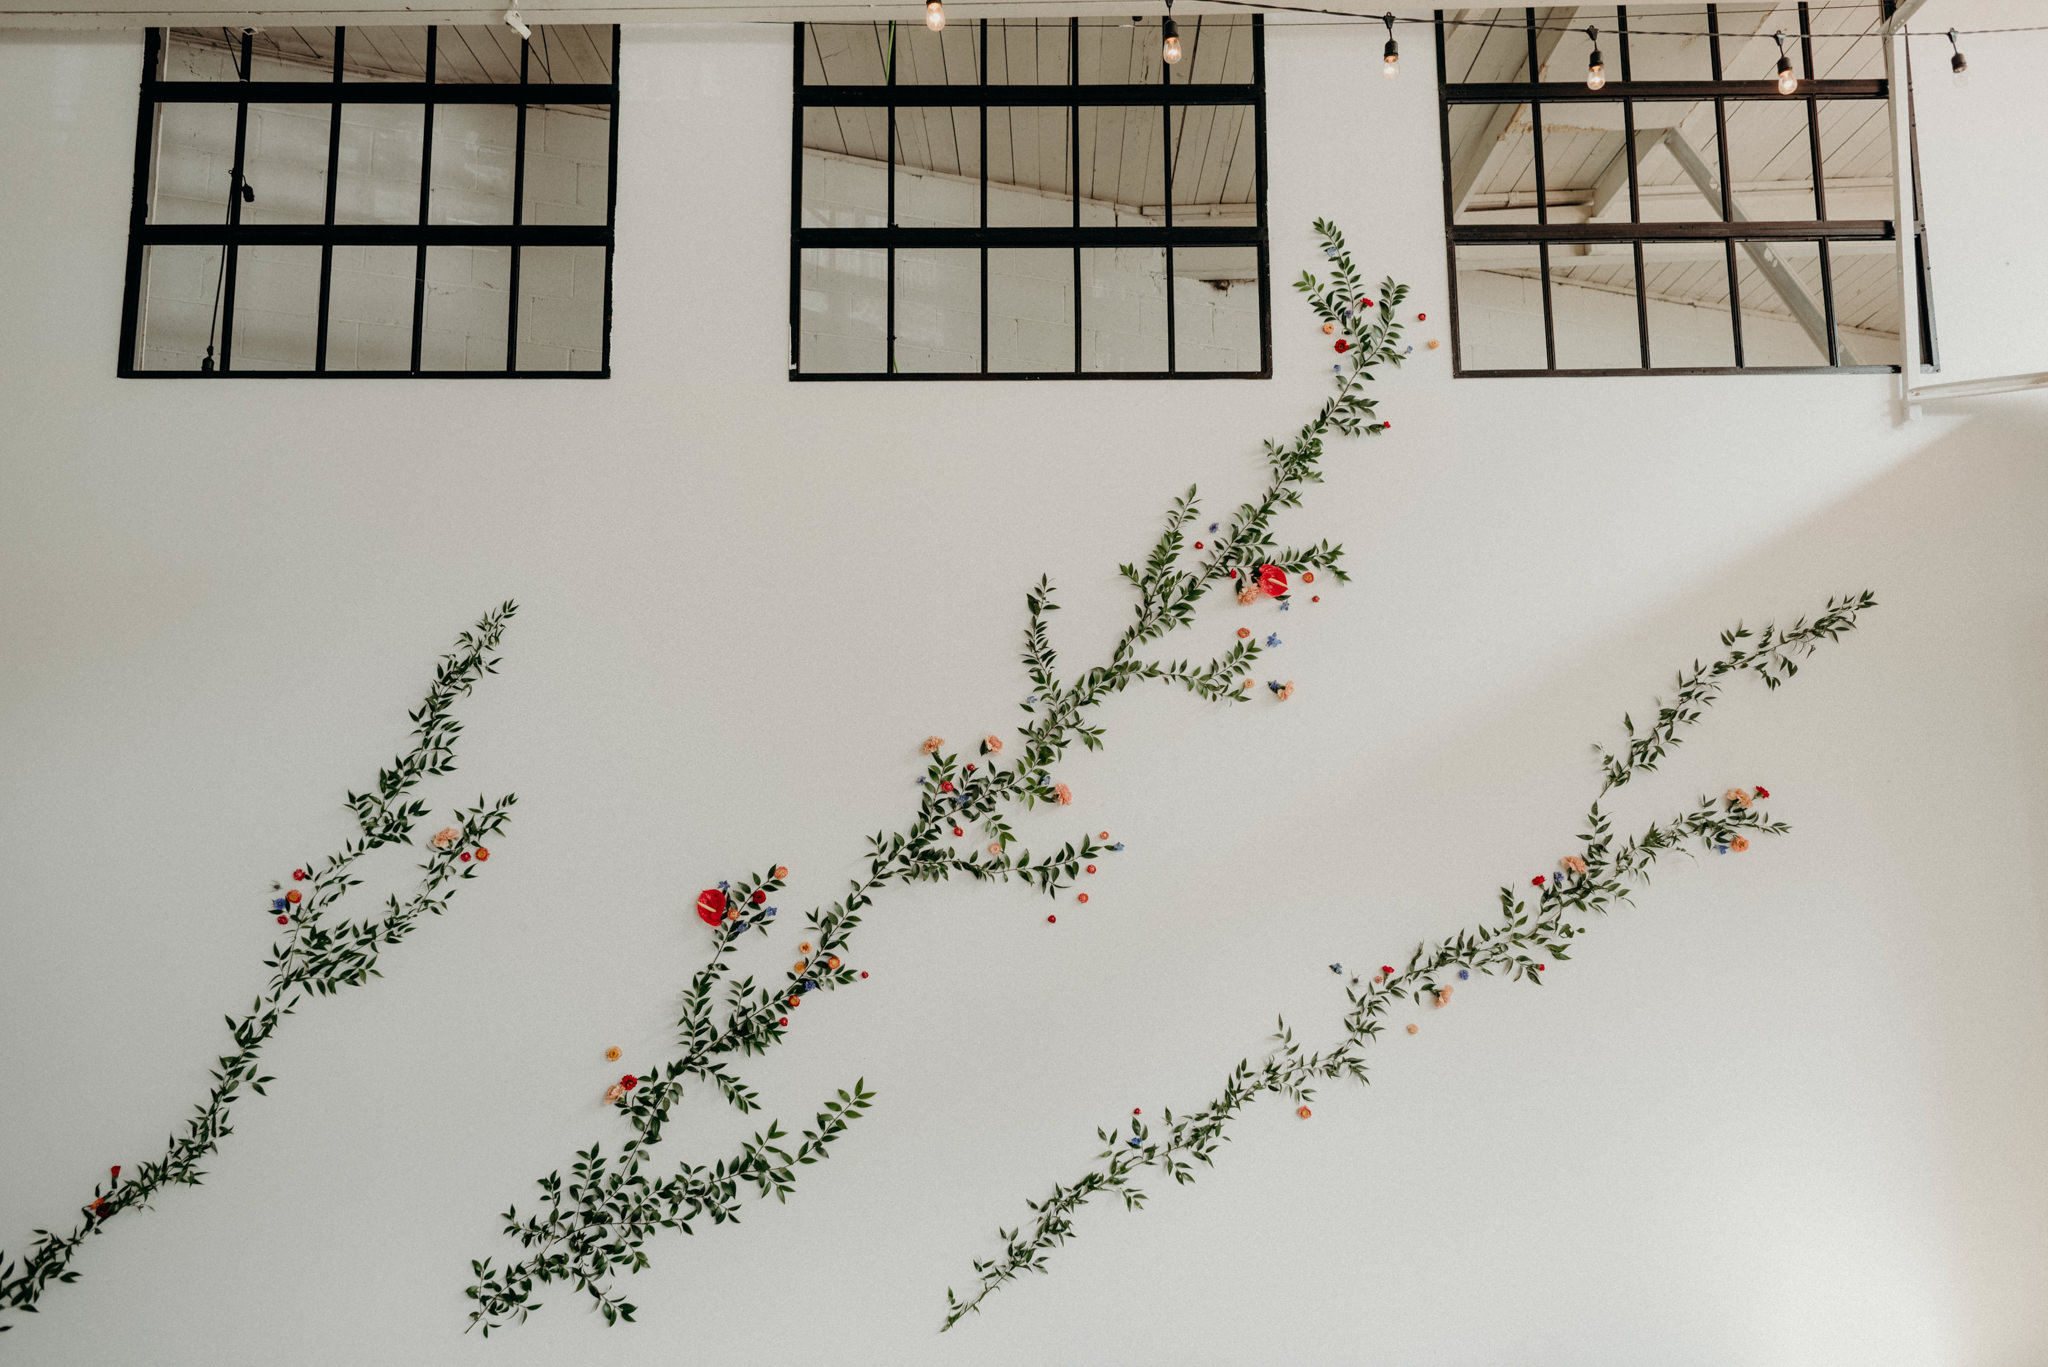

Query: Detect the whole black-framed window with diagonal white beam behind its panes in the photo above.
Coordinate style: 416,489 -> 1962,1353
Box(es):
1436,2 -> 1931,375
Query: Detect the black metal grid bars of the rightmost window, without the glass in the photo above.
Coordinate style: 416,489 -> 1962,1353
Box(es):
1436,0 -> 1900,379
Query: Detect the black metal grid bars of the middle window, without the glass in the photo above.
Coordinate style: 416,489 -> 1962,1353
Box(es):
788,14 -> 1274,383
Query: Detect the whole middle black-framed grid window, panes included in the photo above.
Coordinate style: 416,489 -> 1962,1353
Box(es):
788,14 -> 1272,379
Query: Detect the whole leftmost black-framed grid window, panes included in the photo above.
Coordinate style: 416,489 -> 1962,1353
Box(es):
119,25 -> 618,379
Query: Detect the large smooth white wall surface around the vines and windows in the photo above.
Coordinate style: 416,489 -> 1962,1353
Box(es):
0,4 -> 2048,1367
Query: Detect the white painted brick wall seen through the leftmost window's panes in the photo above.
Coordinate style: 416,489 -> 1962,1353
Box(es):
141,47 -> 610,371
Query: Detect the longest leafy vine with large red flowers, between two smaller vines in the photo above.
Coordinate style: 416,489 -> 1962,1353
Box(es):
465,219 -> 1407,1334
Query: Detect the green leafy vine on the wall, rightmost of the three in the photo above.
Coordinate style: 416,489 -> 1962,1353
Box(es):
944,592 -> 1876,1330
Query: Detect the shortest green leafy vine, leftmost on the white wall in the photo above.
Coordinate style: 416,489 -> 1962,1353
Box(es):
0,603 -> 518,1332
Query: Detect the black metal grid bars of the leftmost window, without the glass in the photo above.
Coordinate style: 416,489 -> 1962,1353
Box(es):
115,25 -> 621,379
